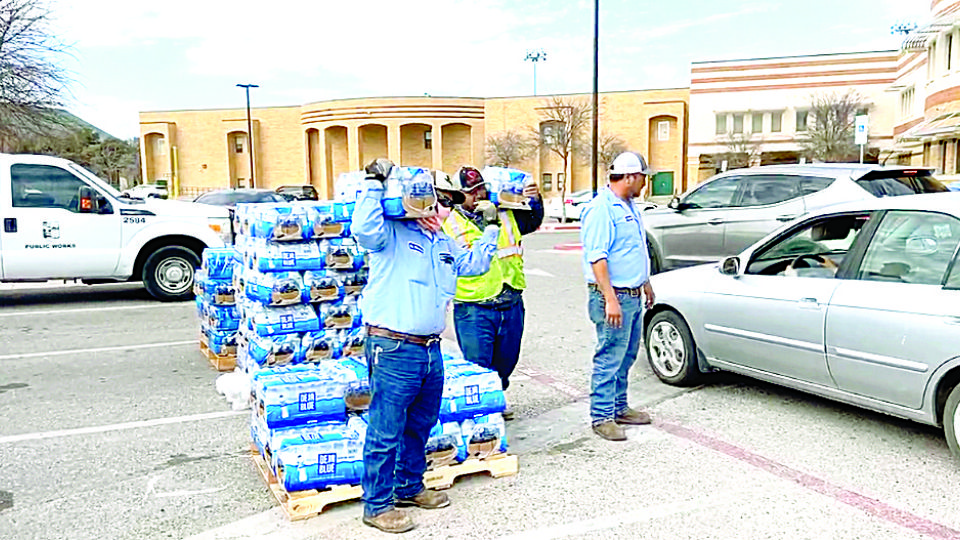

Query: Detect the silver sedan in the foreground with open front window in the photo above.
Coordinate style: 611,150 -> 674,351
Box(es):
644,193 -> 960,458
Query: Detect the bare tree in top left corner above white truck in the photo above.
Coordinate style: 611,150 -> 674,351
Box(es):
0,0 -> 70,149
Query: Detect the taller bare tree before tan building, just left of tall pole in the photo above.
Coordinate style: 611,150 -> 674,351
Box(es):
534,96 -> 592,220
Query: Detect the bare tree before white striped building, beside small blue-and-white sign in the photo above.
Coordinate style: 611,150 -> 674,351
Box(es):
797,89 -> 866,162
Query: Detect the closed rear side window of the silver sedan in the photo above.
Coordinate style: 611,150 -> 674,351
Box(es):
857,211 -> 960,285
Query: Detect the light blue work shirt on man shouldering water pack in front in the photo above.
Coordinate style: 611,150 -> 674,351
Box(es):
350,180 -> 497,336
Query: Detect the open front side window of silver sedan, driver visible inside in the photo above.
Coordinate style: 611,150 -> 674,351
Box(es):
747,213 -> 870,278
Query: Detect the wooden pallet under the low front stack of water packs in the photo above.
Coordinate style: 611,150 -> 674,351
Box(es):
252,448 -> 519,521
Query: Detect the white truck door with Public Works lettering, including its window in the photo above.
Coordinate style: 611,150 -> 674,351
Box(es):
0,164 -> 120,280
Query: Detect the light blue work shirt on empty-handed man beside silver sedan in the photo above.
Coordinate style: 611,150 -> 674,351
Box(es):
580,186 -> 650,288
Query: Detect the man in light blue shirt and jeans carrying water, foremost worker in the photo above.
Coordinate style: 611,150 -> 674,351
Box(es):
351,159 -> 499,533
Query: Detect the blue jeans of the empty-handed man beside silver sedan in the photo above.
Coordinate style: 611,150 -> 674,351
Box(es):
587,287 -> 643,425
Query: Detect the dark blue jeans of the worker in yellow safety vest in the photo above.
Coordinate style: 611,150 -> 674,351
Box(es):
453,298 -> 526,390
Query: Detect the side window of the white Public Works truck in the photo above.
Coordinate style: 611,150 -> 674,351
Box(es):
10,164 -> 87,212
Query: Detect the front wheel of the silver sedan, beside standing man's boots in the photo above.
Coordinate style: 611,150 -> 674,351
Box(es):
643,311 -> 701,386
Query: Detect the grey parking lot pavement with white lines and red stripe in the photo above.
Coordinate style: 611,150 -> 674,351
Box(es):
0,237 -> 960,540
